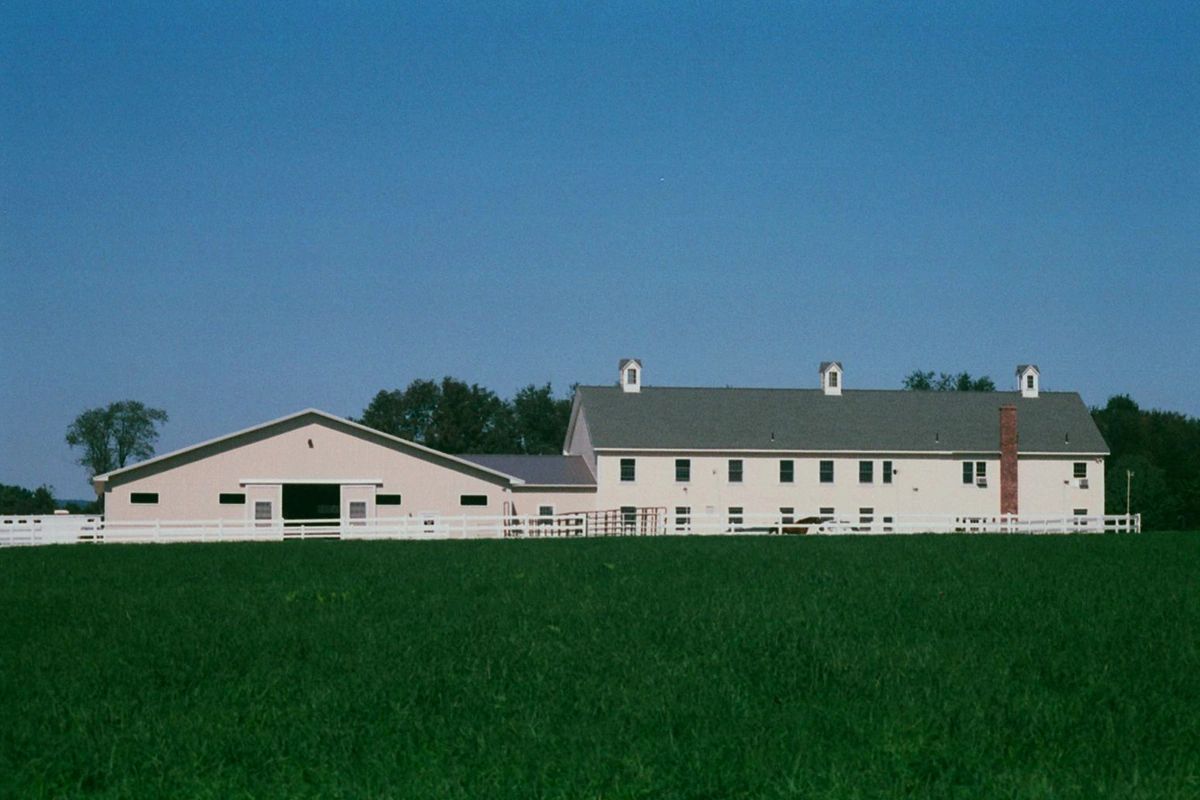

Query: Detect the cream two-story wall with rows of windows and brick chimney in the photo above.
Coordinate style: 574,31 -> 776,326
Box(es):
596,451 -> 1104,518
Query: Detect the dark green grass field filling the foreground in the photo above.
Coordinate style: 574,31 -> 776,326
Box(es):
0,534 -> 1200,799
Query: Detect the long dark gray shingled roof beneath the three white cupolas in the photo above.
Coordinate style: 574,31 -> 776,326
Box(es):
576,386 -> 1109,455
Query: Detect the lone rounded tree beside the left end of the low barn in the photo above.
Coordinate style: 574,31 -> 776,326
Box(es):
66,401 -> 167,479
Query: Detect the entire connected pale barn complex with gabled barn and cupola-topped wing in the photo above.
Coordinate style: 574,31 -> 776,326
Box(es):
95,359 -> 1108,530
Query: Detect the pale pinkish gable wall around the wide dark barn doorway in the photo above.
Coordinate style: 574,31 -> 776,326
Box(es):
104,421 -> 506,522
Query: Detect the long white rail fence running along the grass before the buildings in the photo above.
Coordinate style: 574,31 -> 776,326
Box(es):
0,509 -> 1141,547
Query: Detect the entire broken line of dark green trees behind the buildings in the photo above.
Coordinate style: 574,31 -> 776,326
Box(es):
0,369 -> 1200,530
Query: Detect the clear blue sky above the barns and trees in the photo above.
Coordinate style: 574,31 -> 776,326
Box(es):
0,1 -> 1200,498
